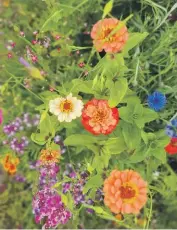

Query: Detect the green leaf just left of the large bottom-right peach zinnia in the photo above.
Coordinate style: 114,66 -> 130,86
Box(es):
83,174 -> 103,194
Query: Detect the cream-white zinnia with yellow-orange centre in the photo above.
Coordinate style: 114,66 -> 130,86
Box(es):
49,93 -> 83,122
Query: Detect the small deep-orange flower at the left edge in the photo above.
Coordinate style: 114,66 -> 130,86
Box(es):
1,154 -> 20,175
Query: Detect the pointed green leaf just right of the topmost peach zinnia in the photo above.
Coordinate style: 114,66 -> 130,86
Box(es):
122,32 -> 148,57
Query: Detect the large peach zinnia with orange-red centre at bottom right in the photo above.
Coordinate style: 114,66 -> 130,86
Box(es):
103,170 -> 147,214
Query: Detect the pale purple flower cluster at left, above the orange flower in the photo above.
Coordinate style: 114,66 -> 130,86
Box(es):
2,113 -> 40,154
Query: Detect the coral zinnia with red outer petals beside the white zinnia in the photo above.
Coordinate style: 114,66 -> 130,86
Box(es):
82,99 -> 119,135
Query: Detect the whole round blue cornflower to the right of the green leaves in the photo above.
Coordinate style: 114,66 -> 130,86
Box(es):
148,91 -> 167,111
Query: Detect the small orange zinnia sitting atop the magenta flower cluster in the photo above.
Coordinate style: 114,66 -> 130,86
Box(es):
39,149 -> 60,164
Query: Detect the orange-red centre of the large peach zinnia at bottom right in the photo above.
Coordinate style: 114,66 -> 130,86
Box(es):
120,183 -> 138,203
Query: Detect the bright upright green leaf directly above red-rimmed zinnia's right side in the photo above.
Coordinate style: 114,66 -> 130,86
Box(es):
108,78 -> 128,108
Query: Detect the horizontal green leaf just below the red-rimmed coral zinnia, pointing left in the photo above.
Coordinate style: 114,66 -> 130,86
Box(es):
64,134 -> 97,146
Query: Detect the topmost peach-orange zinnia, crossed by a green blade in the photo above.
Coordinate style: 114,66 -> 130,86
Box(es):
91,18 -> 128,53
